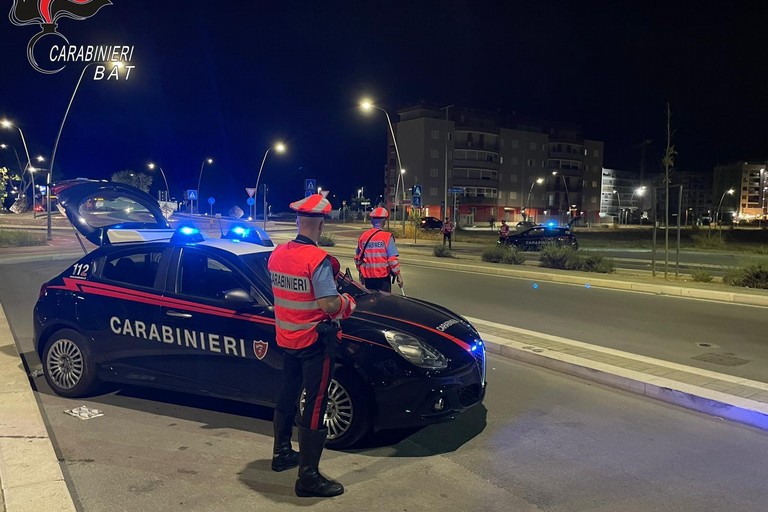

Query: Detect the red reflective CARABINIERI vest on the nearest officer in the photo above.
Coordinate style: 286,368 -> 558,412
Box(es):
267,241 -> 328,349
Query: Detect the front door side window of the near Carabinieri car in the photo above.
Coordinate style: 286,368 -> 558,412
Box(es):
178,249 -> 255,300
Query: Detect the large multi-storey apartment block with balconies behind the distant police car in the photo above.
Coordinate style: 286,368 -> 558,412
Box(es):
392,104 -> 603,225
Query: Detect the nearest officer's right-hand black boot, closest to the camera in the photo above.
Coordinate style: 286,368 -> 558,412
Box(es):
296,427 -> 344,498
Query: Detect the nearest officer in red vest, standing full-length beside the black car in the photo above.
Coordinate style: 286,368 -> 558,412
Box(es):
268,194 -> 355,497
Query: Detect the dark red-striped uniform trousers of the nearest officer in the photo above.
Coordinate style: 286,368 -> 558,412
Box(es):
275,334 -> 337,430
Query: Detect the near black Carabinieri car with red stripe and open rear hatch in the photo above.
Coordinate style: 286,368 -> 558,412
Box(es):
34,180 -> 486,448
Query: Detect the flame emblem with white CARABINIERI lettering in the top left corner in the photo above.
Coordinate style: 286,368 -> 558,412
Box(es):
8,0 -> 112,75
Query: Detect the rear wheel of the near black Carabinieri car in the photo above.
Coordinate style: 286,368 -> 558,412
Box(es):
43,329 -> 99,398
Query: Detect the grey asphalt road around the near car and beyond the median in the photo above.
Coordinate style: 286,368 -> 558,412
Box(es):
0,261 -> 768,512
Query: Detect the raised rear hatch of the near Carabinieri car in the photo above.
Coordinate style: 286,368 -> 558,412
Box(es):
53,179 -> 170,245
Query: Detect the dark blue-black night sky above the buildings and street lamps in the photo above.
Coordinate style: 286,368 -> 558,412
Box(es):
0,0 -> 768,211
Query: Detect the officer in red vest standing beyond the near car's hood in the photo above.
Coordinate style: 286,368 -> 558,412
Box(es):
355,207 -> 403,292
